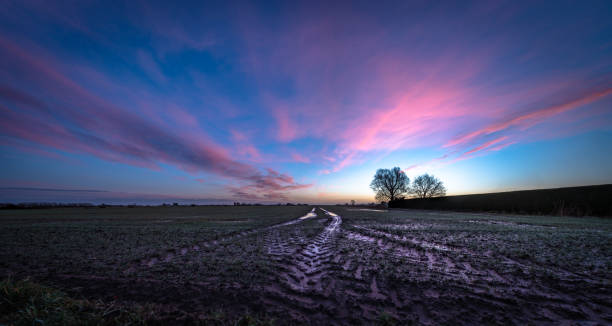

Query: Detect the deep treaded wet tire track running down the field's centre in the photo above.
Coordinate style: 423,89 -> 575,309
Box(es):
263,209 -> 404,324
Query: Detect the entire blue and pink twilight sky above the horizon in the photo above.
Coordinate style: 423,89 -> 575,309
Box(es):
0,0 -> 612,203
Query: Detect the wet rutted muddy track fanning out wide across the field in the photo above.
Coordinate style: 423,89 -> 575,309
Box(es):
2,209 -> 612,325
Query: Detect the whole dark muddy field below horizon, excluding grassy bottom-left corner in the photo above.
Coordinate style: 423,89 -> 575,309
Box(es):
0,206 -> 612,325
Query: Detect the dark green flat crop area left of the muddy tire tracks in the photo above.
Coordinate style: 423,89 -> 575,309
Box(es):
0,206 -> 309,276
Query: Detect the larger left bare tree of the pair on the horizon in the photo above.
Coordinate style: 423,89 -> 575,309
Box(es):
370,167 -> 410,201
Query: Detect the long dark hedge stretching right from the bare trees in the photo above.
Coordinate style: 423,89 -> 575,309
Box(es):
389,185 -> 612,217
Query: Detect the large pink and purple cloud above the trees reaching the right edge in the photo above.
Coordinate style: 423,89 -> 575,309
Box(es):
231,1 -> 607,173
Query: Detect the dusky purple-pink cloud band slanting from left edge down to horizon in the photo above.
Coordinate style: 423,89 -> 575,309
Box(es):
0,38 -> 306,198
